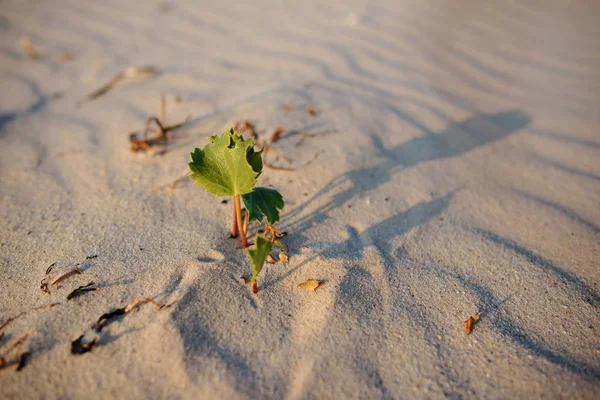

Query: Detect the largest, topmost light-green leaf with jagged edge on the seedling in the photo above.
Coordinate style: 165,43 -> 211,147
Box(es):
188,130 -> 262,196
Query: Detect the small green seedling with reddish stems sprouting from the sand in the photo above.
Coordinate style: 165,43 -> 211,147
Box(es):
188,129 -> 284,293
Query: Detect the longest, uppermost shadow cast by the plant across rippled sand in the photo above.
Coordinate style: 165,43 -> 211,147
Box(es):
286,110 -> 531,231
